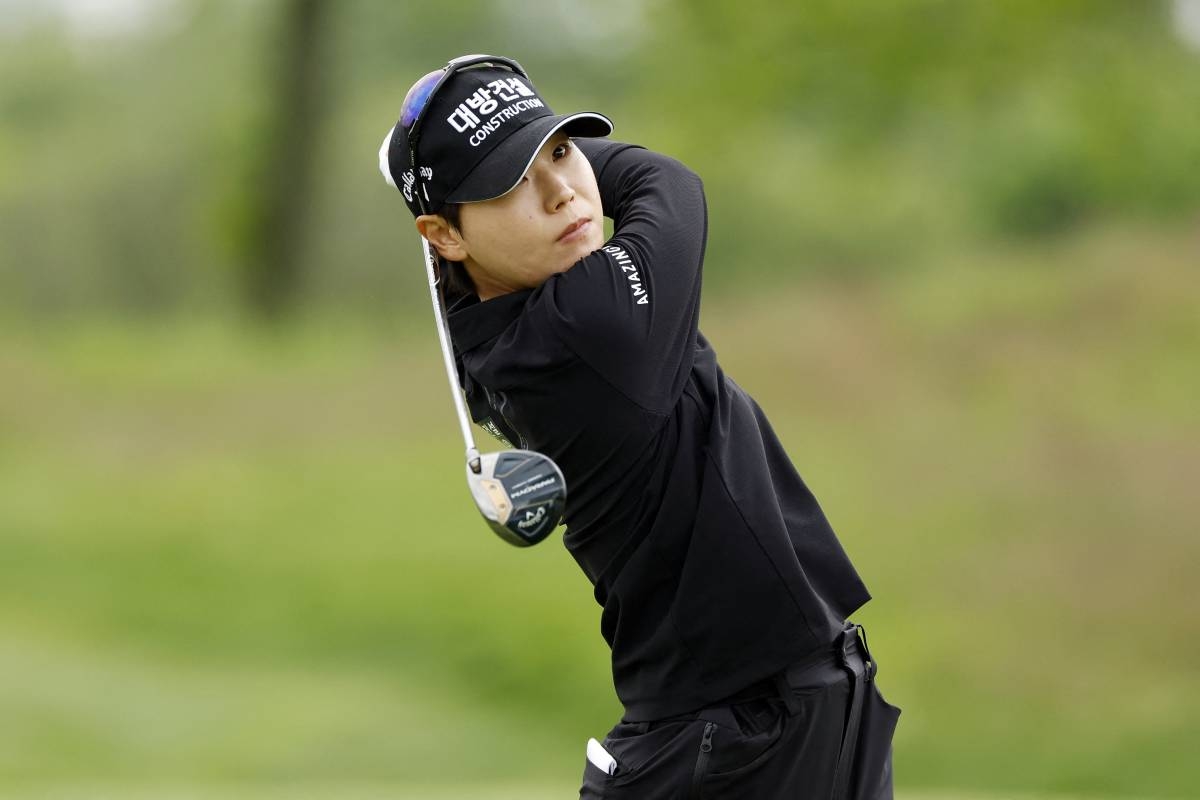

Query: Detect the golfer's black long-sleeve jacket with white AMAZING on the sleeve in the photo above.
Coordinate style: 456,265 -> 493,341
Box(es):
449,139 -> 870,721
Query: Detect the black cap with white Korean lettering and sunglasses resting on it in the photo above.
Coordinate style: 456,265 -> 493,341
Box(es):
379,56 -> 612,217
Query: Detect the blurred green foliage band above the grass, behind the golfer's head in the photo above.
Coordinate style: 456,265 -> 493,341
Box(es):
0,0 -> 1200,315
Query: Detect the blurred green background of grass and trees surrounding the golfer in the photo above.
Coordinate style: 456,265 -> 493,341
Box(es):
0,0 -> 1200,800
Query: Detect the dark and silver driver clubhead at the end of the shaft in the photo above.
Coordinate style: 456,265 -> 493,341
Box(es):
467,450 -> 566,547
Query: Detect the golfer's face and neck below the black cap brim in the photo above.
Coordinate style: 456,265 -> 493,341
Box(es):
461,133 -> 604,300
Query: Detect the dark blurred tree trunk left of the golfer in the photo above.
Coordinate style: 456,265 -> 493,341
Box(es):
240,0 -> 330,320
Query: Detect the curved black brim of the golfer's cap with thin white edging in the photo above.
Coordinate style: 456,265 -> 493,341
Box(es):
446,112 -> 612,203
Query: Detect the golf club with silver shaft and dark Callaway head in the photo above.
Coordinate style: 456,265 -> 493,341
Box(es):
421,236 -> 566,547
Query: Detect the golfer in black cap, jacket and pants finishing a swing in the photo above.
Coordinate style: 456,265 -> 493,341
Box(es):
380,56 -> 899,800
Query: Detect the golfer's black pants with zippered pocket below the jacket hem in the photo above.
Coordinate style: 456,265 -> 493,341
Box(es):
580,624 -> 900,800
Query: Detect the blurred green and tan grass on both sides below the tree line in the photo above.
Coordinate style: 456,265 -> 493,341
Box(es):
0,224 -> 1200,798
